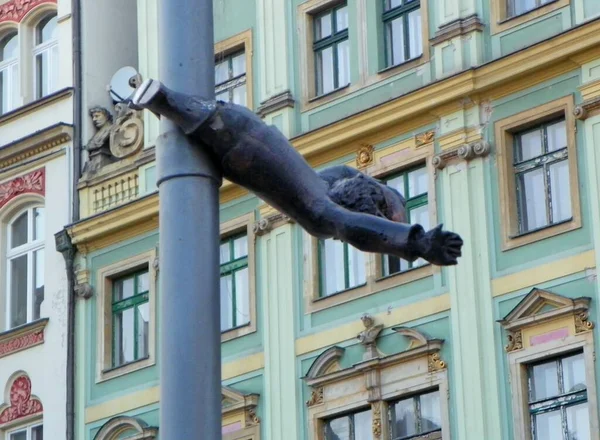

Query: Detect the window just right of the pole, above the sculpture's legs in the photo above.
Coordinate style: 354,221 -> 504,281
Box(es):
215,51 -> 247,105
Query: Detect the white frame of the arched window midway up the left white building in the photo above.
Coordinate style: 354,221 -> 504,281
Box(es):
5,204 -> 45,330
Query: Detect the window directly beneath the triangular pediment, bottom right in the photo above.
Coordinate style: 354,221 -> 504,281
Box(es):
528,352 -> 590,440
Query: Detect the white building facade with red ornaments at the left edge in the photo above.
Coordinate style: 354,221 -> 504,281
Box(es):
0,0 -> 73,440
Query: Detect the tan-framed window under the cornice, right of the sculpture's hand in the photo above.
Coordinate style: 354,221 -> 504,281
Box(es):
494,95 -> 582,251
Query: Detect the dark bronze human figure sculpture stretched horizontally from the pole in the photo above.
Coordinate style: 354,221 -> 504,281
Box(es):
130,79 -> 463,266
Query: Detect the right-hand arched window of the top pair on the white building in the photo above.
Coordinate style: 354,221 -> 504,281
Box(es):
33,14 -> 58,99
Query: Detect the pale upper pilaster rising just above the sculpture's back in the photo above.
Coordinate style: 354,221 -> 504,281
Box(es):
256,0 -> 295,137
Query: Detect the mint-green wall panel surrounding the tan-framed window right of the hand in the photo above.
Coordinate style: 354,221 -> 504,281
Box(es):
486,71 -> 596,277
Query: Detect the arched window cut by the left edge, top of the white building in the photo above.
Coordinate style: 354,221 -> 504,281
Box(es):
0,32 -> 19,114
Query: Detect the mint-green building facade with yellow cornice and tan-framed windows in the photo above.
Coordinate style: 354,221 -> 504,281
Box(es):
68,0 -> 600,440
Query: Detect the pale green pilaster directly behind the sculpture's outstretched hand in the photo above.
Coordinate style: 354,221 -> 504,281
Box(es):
434,111 -> 501,440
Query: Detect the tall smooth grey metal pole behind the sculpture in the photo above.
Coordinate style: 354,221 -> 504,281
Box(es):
156,0 -> 221,440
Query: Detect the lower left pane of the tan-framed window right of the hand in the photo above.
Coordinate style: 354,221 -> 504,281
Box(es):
518,168 -> 548,232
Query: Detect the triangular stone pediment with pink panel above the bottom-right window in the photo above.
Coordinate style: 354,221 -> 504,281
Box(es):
498,288 -> 594,352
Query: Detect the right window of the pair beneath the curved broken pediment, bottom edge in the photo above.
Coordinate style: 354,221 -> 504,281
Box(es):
388,390 -> 442,440
